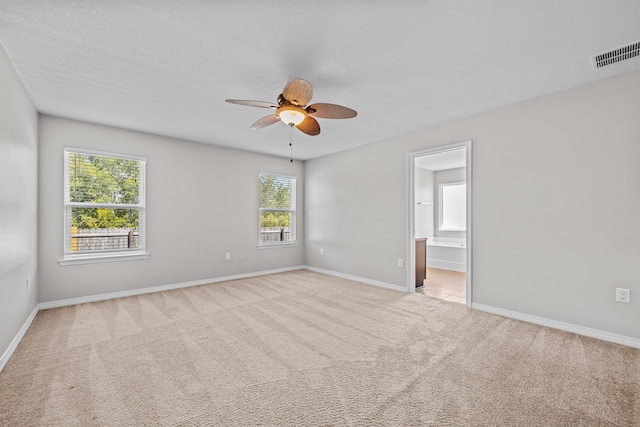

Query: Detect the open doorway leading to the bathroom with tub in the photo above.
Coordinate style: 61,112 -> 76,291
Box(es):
407,141 -> 473,307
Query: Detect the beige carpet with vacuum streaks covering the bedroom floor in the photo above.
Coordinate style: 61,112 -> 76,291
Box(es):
0,270 -> 640,426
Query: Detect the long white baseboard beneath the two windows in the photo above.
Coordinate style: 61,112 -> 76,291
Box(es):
38,265 -> 305,310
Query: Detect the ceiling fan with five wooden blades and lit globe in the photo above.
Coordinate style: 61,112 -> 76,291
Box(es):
226,79 -> 358,136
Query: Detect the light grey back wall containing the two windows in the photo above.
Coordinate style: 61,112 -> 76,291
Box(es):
39,116 -> 304,302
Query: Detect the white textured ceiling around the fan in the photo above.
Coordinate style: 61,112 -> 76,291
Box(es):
0,0 -> 640,160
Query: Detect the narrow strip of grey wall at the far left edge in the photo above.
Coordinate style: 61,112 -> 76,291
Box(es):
0,41 -> 38,362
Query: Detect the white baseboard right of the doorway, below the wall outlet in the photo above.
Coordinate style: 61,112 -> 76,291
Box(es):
471,303 -> 640,348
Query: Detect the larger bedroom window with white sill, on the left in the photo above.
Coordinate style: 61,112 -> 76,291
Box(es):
60,148 -> 148,265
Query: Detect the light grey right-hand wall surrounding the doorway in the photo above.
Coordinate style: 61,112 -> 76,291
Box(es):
305,71 -> 640,338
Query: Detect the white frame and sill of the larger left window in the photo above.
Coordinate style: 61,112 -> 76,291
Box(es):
58,147 -> 149,265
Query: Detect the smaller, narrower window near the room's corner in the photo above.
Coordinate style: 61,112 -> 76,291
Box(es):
258,173 -> 296,247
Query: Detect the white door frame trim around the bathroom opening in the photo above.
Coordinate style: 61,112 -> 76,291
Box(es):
406,140 -> 473,307
